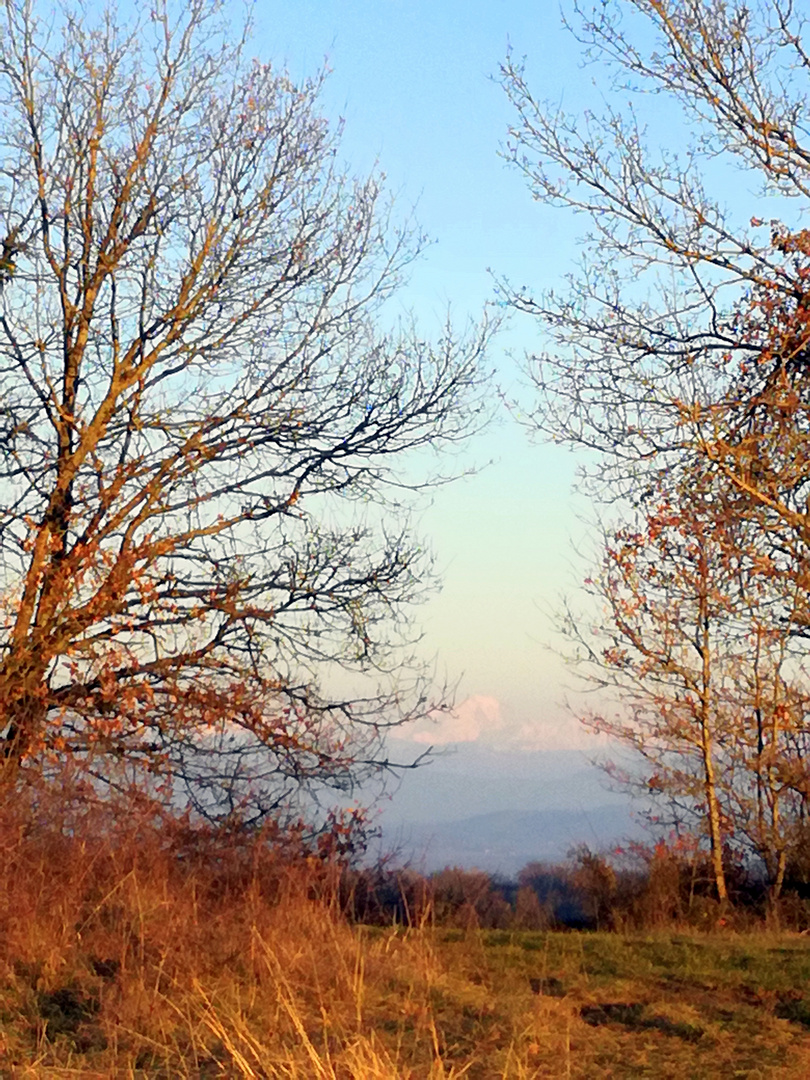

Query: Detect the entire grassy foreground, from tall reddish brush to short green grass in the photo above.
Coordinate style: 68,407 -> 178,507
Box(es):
0,790 -> 810,1080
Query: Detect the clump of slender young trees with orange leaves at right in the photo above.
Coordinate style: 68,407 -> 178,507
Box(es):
562,476 -> 808,901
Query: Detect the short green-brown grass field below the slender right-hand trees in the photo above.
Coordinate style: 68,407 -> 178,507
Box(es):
442,933 -> 810,1080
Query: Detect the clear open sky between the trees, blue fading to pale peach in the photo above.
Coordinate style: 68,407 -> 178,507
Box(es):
253,0 -> 609,790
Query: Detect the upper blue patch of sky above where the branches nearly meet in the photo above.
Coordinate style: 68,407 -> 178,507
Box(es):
254,0 -> 589,321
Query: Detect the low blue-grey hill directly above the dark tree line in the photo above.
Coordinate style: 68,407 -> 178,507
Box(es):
383,802 -> 643,877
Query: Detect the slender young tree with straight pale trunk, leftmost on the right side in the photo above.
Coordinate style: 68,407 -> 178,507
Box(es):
563,486 -> 733,902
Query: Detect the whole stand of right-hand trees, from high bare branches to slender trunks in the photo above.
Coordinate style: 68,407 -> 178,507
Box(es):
501,0 -> 810,894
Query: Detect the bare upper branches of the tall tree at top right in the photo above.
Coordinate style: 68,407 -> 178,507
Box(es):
502,0 -> 810,497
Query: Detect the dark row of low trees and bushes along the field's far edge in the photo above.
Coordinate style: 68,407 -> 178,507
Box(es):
339,839 -> 810,931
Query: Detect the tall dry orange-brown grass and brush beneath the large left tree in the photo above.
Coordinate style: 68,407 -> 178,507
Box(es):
0,790 -> 548,1080
